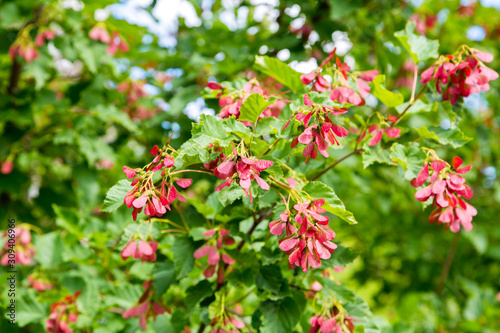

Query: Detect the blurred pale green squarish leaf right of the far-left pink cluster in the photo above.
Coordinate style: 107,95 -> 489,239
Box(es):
34,231 -> 64,268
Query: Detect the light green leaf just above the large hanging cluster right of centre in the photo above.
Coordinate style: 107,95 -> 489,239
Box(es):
302,181 -> 358,224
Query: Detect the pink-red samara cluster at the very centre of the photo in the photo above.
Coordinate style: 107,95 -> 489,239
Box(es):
205,147 -> 274,202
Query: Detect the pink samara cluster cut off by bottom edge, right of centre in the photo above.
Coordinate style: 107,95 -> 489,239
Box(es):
309,306 -> 355,333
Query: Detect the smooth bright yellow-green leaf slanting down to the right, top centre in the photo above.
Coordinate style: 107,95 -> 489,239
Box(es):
253,56 -> 304,92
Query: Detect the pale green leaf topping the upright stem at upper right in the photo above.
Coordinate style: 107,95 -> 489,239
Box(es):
394,21 -> 439,63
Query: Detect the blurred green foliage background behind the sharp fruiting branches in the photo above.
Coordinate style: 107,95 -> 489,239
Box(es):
0,0 -> 500,332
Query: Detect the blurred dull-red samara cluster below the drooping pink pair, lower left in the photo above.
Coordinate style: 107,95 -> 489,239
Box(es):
122,280 -> 170,330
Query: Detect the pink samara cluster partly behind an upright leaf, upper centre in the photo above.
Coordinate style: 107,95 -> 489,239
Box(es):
207,79 -> 290,126
